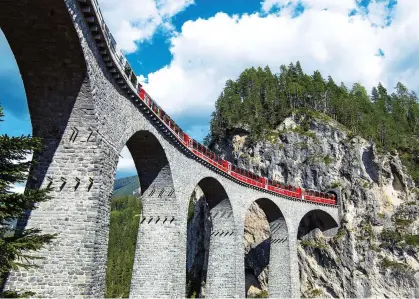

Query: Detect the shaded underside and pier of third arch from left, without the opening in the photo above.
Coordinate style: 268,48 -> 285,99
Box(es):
190,177 -> 238,297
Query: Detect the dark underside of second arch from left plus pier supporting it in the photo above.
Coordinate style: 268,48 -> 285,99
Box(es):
121,130 -> 185,298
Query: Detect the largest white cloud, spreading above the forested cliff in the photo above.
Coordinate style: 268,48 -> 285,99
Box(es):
139,0 -> 419,117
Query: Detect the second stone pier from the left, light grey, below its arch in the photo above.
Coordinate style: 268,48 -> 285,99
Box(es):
130,202 -> 186,298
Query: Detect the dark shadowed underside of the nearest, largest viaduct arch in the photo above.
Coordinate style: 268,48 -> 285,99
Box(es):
0,0 -> 91,187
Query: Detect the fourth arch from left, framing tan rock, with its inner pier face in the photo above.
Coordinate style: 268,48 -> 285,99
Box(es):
244,198 -> 290,297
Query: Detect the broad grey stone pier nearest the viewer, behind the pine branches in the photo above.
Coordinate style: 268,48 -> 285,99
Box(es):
6,122 -> 118,297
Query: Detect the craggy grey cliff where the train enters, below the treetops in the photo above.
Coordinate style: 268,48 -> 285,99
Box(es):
215,113 -> 419,297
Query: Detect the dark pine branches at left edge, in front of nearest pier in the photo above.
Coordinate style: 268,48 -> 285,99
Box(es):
0,106 -> 55,297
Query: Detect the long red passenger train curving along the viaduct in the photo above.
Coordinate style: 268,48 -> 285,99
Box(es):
137,84 -> 336,206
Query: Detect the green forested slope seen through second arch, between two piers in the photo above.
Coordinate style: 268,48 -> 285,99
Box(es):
106,196 -> 142,298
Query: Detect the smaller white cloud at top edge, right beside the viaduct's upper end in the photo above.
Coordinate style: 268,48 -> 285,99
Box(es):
98,0 -> 194,53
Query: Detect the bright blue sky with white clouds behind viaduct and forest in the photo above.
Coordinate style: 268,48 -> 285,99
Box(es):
0,0 -> 419,177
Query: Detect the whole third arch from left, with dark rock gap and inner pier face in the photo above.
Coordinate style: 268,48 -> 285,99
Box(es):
186,177 -> 237,297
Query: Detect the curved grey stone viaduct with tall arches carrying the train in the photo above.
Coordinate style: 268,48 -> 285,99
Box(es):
0,0 -> 339,297
